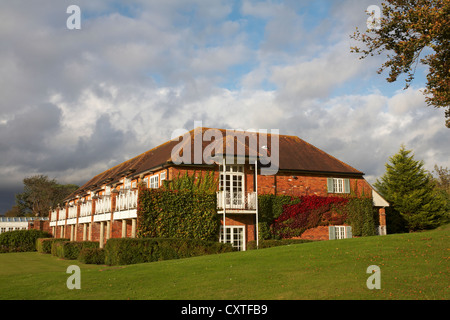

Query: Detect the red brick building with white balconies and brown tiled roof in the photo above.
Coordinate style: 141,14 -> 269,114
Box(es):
50,128 -> 388,250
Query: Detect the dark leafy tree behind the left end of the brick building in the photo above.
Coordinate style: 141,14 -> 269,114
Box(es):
16,175 -> 78,217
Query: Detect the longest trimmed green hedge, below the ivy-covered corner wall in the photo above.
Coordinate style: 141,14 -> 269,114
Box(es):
105,238 -> 234,265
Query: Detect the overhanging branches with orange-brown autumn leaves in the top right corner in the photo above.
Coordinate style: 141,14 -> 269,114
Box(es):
350,0 -> 450,128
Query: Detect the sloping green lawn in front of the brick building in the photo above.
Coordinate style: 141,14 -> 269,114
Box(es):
0,225 -> 450,300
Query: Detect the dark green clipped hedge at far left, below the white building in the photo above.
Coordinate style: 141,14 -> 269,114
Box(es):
0,230 -> 51,252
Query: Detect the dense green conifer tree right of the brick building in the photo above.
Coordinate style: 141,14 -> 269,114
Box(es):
374,146 -> 447,231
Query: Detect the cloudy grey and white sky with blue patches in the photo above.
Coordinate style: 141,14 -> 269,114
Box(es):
0,0 -> 450,213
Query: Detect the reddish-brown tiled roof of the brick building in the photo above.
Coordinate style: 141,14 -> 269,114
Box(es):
68,128 -> 363,199
